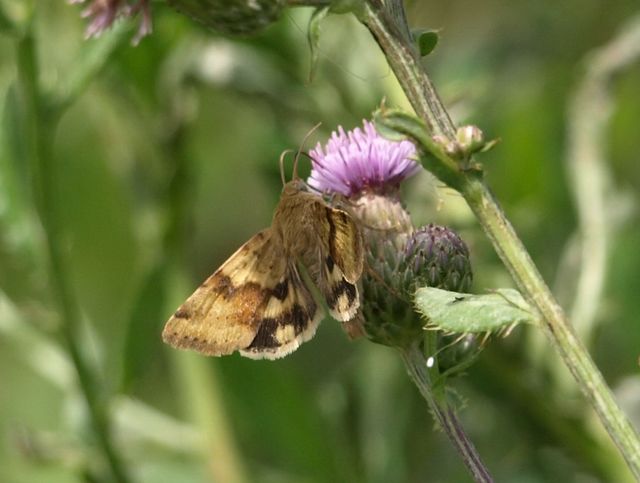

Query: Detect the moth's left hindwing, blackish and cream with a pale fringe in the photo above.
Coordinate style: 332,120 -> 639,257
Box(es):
240,262 -> 323,359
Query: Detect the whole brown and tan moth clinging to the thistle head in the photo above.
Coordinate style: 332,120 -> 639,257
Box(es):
162,167 -> 363,359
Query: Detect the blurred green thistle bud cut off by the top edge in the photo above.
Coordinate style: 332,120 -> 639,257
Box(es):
168,0 -> 284,35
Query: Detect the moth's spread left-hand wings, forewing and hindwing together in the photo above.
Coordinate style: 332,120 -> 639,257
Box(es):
162,229 -> 322,359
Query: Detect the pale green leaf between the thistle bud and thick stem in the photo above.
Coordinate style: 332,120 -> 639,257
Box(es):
414,287 -> 536,333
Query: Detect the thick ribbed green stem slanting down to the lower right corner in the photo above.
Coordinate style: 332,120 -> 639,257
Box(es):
362,0 -> 640,479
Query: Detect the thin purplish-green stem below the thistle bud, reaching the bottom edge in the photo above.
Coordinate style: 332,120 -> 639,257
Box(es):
401,345 -> 493,483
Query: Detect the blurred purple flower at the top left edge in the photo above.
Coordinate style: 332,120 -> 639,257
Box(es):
70,0 -> 151,45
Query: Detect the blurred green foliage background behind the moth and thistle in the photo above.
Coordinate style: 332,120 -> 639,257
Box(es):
0,0 -> 640,483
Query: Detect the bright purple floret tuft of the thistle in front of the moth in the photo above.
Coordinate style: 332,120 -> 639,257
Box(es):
307,120 -> 420,196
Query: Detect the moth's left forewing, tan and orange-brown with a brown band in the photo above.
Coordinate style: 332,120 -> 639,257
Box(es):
162,229 -> 286,356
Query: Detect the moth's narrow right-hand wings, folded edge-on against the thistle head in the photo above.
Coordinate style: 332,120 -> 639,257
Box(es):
314,204 -> 364,322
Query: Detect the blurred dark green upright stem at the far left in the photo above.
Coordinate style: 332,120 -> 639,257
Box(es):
17,33 -> 130,483
